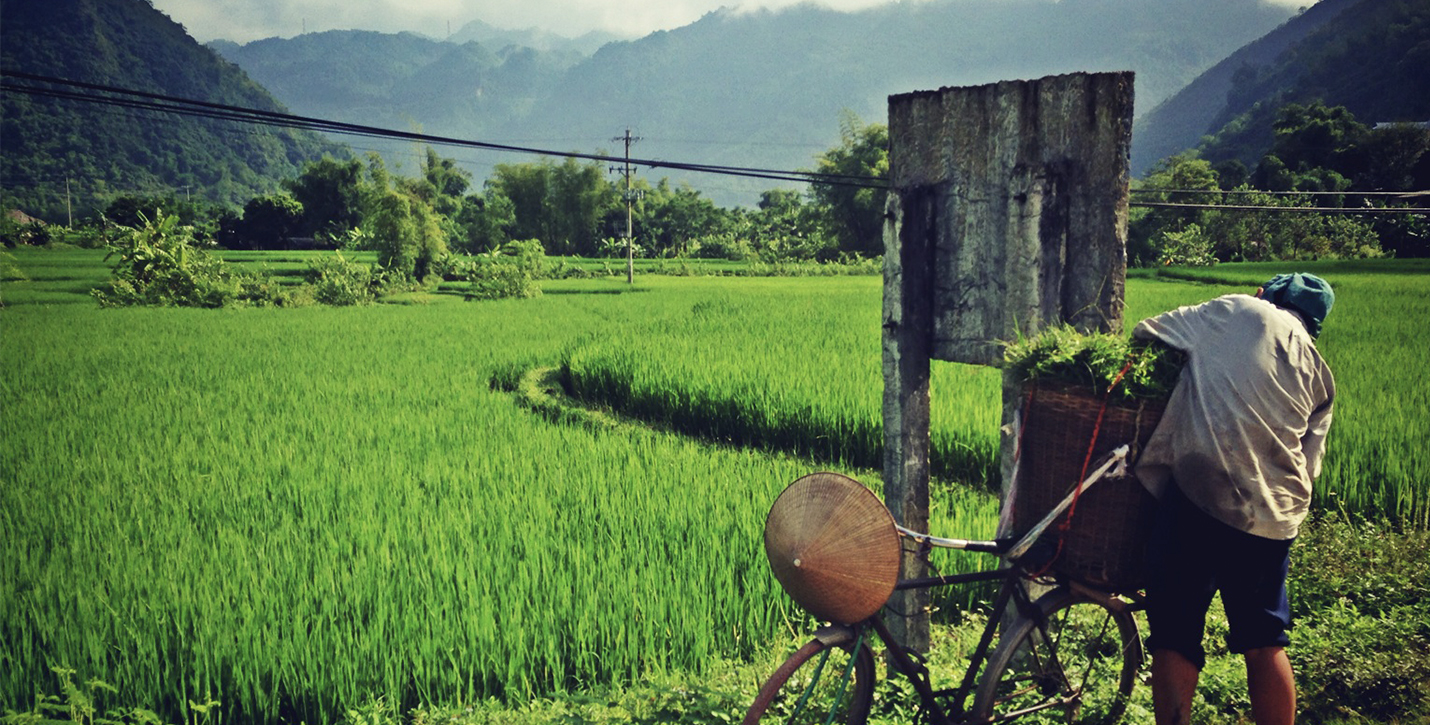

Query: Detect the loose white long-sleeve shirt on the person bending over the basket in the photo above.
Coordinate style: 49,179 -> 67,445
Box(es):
1133,295 -> 1336,539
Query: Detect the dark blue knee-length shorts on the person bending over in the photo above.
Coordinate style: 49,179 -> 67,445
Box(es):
1147,485 -> 1294,669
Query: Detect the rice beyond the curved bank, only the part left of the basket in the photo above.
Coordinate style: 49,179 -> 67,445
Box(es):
563,277 -> 1000,494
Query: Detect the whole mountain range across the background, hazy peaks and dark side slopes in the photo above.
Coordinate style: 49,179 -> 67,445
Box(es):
0,0 -> 1430,220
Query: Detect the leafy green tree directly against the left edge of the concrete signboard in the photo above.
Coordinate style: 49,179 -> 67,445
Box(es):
814,112 -> 889,256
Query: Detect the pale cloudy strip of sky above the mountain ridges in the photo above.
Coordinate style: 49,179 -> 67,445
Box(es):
153,0 -> 1313,43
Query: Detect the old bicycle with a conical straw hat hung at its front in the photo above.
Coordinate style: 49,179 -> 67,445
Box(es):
744,446 -> 1143,725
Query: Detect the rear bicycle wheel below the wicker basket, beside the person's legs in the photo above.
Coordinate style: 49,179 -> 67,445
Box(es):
972,589 -> 1143,725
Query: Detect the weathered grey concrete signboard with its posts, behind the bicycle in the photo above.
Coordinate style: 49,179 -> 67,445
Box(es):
884,73 -> 1133,649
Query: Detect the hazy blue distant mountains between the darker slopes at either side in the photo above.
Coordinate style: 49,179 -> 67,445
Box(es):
215,0 -> 1291,204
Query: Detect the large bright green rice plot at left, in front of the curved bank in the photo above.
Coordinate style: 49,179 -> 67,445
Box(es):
0,285 -> 808,722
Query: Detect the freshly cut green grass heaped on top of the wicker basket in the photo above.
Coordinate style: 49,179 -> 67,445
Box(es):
1004,325 -> 1185,399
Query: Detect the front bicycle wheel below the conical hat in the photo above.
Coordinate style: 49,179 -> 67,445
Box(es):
744,639 -> 874,725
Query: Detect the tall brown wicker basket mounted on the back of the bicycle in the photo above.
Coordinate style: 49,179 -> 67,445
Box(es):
1012,383 -> 1165,592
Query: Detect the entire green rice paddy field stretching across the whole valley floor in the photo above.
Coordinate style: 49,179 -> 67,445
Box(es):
0,249 -> 1430,722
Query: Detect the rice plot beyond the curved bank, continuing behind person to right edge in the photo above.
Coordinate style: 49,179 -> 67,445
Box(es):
566,262 -> 1430,528
